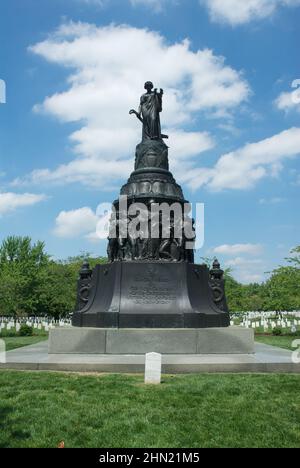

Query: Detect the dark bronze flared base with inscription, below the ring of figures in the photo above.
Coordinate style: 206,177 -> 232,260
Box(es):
72,261 -> 230,329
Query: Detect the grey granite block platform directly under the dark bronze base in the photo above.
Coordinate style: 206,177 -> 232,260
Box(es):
49,327 -> 254,355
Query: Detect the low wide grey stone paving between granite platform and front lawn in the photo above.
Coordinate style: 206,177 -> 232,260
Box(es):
0,341 -> 300,374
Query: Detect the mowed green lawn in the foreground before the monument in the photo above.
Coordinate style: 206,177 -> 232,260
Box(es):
0,371 -> 300,448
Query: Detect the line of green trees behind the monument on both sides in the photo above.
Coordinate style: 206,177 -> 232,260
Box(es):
0,236 -> 300,318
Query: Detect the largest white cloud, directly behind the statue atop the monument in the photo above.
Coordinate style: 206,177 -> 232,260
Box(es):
15,22 -> 250,188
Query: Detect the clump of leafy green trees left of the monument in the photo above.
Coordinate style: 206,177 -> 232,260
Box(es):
0,236 -> 106,318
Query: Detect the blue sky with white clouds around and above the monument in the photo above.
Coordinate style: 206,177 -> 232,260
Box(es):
0,0 -> 300,282
